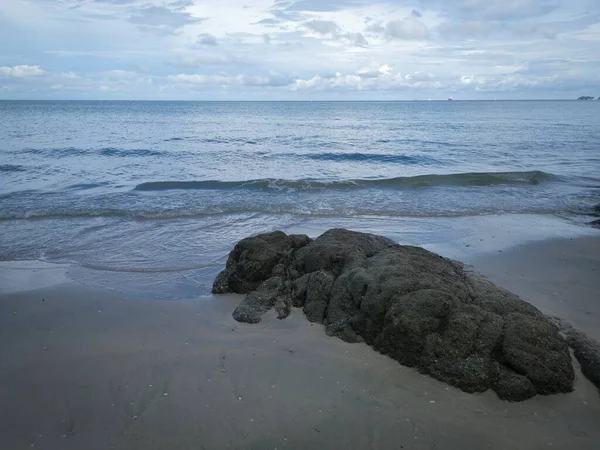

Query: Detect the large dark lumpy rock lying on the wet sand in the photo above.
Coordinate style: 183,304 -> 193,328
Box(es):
213,229 -> 574,401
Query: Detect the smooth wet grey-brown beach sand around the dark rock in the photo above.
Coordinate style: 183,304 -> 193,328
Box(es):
0,237 -> 600,450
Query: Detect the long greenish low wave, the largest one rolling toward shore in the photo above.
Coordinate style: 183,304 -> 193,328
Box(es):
134,171 -> 562,191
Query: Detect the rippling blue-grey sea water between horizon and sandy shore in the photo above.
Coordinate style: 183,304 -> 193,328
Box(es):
0,101 -> 600,296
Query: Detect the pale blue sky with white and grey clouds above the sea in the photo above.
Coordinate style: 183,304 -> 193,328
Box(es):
0,0 -> 600,100
